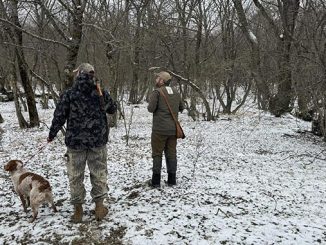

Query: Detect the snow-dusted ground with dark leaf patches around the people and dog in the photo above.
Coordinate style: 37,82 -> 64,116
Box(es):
0,99 -> 326,245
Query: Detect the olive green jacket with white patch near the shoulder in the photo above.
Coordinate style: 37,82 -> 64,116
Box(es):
147,85 -> 184,135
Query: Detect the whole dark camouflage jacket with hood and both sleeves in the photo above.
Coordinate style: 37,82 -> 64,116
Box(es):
49,74 -> 117,149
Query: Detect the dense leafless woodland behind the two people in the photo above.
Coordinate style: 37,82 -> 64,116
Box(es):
0,0 -> 326,141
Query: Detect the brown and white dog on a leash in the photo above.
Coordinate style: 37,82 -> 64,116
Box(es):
4,160 -> 57,222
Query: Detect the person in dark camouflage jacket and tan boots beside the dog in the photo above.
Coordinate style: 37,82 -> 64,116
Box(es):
48,63 -> 117,223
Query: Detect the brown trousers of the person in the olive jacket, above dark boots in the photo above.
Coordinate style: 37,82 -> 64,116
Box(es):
151,132 -> 177,174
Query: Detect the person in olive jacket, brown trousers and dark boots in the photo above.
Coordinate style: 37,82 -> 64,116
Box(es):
147,72 -> 184,187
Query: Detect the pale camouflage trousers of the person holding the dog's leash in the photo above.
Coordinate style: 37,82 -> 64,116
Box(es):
66,146 -> 109,204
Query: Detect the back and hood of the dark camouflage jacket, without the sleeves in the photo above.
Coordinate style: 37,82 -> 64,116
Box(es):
60,74 -> 108,149
